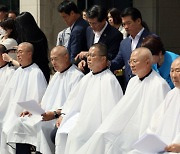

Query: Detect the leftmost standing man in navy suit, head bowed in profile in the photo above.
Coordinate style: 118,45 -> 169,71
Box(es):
58,0 -> 88,62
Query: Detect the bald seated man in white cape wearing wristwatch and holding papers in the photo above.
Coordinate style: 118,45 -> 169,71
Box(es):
0,46 -> 83,154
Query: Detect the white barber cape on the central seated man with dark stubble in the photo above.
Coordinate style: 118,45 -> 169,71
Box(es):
56,69 -> 123,154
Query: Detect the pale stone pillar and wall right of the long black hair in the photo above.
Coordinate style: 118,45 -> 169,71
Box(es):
20,0 -> 66,50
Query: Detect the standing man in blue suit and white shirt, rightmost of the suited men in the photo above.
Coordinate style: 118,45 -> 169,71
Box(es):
110,7 -> 151,91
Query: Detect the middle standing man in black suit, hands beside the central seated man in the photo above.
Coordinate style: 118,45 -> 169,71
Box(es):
76,5 -> 123,73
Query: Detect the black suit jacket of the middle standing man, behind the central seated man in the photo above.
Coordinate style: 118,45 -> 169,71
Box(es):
86,24 -> 123,60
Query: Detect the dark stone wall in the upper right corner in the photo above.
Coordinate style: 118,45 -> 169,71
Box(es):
133,0 -> 180,54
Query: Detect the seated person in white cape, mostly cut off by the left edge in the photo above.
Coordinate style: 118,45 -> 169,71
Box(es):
0,44 -> 14,96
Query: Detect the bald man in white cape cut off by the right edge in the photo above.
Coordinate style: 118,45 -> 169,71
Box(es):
132,57 -> 180,154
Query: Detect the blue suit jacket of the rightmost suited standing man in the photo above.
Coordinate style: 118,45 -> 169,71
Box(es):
110,29 -> 152,87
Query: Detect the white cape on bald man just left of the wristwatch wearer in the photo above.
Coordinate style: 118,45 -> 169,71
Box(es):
0,63 -> 47,154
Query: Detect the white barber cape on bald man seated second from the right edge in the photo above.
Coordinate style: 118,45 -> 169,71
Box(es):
76,71 -> 170,154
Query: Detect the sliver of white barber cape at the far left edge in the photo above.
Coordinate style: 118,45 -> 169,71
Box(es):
0,63 -> 15,97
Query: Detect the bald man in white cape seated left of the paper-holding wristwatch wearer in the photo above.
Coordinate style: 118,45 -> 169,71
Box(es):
0,42 -> 47,154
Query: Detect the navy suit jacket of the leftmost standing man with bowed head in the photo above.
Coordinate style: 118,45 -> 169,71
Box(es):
67,17 -> 89,62
